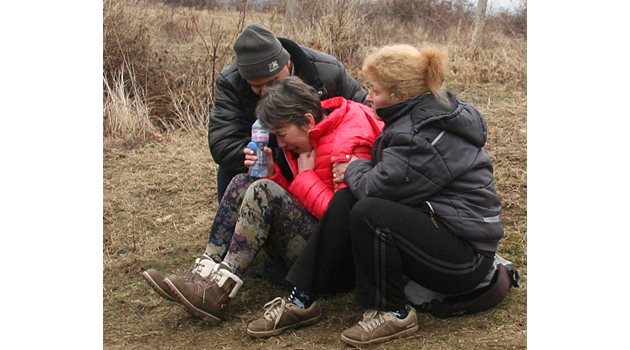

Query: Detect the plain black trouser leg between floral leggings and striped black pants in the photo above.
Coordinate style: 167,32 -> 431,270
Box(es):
287,188 -> 356,298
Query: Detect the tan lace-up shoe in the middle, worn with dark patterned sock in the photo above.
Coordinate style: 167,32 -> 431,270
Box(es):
247,297 -> 322,338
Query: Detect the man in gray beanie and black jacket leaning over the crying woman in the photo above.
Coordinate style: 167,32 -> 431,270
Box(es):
208,24 -> 367,201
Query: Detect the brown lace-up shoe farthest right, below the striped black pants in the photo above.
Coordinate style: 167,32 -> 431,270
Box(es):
341,306 -> 418,347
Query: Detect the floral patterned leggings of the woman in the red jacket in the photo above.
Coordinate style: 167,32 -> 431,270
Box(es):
206,174 -> 317,276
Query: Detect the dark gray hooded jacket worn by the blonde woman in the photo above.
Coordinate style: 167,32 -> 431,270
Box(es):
345,93 -> 503,252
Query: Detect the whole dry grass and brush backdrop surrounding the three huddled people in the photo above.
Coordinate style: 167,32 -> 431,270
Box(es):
103,0 -> 527,349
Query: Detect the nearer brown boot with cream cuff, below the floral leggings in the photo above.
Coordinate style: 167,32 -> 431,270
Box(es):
164,263 -> 243,324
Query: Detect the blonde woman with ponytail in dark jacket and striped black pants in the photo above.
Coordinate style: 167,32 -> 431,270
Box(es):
333,45 -> 503,346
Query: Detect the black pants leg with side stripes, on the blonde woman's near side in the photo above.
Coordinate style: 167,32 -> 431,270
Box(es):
350,198 -> 494,311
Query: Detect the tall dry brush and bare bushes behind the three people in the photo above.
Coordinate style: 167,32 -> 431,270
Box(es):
103,0 -> 527,144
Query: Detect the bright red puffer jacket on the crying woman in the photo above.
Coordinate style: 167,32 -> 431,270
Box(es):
270,97 -> 383,219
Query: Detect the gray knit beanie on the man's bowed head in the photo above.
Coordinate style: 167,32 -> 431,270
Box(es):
234,24 -> 289,80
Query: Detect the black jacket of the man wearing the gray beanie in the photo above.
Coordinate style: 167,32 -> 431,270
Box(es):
208,38 -> 367,172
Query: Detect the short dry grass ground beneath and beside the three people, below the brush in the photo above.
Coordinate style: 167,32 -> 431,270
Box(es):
103,86 -> 527,349
